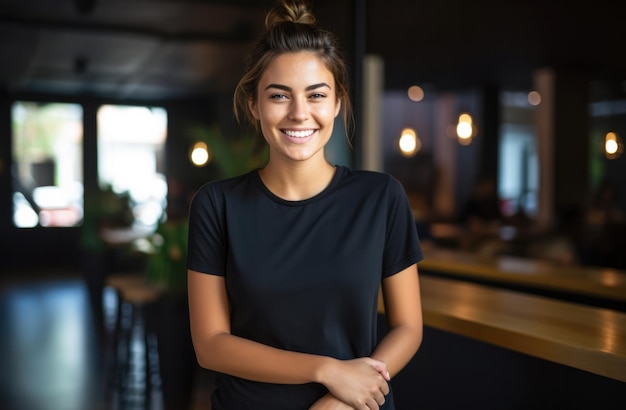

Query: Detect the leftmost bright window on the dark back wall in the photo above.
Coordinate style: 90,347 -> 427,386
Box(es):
11,101 -> 83,228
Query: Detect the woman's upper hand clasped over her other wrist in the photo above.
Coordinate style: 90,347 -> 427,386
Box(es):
323,357 -> 389,410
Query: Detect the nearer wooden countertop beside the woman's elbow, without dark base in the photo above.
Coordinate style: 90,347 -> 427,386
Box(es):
421,276 -> 626,388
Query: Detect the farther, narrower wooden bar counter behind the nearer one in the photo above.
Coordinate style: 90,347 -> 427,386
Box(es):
419,247 -> 626,311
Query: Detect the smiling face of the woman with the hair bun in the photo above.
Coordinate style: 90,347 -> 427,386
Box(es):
250,52 -> 341,161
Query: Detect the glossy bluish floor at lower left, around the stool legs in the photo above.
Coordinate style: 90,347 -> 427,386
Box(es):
0,272 -> 211,410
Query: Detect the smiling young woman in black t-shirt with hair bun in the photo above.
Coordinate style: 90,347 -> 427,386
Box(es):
187,0 -> 422,410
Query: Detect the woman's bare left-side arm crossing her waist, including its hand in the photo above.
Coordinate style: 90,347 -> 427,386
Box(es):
188,270 -> 389,409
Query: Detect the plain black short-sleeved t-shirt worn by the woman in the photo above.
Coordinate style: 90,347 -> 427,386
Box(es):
187,166 -> 422,410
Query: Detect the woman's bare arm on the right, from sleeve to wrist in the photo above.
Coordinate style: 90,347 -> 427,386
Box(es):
372,264 -> 423,376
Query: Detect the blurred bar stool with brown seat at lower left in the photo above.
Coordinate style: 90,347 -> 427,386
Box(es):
105,272 -> 161,409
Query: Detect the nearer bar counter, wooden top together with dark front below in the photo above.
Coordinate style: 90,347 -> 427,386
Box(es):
379,275 -> 626,410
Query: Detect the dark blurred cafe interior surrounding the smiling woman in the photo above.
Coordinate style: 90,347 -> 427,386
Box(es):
0,0 -> 626,410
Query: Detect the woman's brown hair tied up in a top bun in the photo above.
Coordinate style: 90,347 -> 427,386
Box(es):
233,0 -> 353,142
